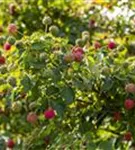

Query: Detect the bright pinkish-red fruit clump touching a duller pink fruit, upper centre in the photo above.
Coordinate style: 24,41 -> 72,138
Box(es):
72,47 -> 84,62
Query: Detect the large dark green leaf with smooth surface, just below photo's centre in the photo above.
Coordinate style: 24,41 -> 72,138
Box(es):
61,87 -> 75,104
